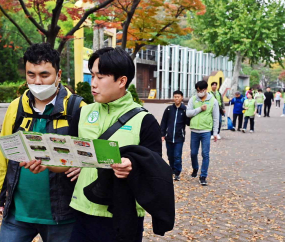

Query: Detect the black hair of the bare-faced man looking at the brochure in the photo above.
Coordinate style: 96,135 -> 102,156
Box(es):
88,47 -> 135,88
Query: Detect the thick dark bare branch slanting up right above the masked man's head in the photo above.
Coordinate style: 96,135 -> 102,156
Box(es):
57,0 -> 114,53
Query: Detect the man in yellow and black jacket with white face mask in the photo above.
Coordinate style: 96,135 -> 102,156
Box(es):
0,43 -> 85,242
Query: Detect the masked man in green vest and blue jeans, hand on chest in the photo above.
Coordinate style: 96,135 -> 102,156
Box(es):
186,81 -> 220,186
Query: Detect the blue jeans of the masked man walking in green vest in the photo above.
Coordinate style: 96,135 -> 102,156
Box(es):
190,131 -> 211,177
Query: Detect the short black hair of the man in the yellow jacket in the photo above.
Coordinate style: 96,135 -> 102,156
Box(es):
23,43 -> 60,72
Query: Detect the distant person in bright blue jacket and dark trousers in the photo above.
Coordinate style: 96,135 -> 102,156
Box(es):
229,92 -> 245,131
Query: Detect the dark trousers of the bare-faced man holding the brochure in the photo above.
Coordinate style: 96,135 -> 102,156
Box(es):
69,212 -> 144,242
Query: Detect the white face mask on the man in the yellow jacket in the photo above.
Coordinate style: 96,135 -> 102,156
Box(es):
28,75 -> 58,101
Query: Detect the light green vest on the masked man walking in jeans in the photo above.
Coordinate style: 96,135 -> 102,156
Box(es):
190,96 -> 215,131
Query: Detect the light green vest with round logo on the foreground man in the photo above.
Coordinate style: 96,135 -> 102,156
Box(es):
70,92 -> 147,217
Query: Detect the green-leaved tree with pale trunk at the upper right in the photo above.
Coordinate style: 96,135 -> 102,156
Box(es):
189,0 -> 285,91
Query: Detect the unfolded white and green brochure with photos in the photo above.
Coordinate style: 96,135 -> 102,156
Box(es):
0,131 -> 121,168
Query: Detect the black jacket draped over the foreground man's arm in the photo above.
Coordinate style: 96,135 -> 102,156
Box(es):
84,145 -> 175,242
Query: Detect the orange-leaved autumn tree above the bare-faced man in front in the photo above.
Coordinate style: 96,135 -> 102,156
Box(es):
97,0 -> 205,58
